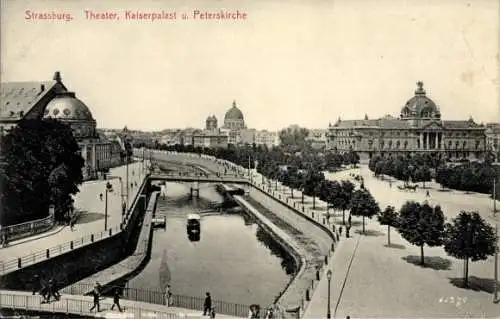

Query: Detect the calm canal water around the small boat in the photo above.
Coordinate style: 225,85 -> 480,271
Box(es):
128,183 -> 296,305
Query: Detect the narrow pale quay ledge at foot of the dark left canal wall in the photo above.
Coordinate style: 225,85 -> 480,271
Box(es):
63,191 -> 160,294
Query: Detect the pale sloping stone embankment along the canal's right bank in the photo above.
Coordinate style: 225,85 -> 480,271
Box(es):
146,151 -> 338,316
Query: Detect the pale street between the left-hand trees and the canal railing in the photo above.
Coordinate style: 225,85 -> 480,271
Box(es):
0,162 -> 148,261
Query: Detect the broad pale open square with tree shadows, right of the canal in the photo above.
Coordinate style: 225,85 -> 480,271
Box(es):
298,167 -> 500,318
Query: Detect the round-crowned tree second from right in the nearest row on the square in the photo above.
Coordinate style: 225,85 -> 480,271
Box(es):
398,201 -> 444,265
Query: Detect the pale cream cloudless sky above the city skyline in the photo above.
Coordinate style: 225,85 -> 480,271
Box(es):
0,0 -> 500,130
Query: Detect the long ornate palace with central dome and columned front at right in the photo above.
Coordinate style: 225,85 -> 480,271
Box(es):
328,82 -> 485,160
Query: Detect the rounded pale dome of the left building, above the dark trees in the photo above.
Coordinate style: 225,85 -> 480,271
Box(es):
44,92 -> 94,121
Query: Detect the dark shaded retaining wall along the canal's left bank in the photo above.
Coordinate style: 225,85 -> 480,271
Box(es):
0,179 -> 151,290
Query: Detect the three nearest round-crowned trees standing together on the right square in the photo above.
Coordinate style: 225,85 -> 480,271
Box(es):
378,201 -> 497,286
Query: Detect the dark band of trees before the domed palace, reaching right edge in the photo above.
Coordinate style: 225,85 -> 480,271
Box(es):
368,153 -> 500,195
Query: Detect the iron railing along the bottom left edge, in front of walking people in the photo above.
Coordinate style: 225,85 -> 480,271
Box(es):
0,293 -> 180,319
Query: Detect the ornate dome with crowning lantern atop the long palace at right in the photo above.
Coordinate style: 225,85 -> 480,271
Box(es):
401,81 -> 441,118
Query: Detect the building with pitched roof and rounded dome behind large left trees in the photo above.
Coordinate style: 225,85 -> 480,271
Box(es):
0,72 -> 121,180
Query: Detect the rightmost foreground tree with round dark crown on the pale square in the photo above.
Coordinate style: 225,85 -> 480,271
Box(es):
444,211 -> 497,287
